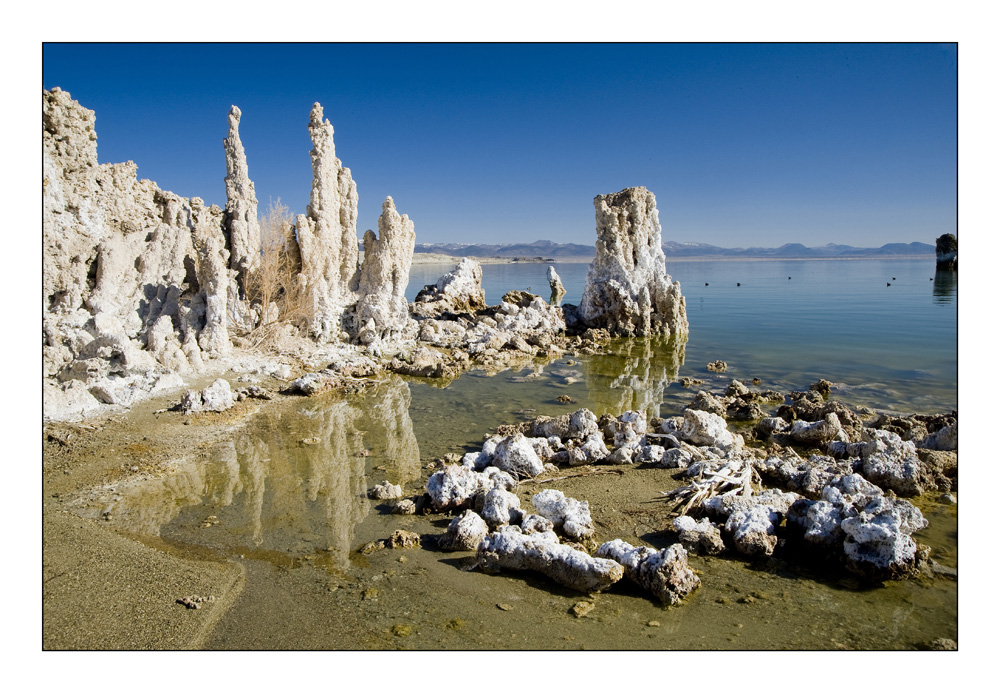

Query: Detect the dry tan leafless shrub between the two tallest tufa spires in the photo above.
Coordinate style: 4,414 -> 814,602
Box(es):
237,198 -> 312,348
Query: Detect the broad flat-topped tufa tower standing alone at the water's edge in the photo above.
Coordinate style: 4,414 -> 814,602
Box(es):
578,187 -> 688,337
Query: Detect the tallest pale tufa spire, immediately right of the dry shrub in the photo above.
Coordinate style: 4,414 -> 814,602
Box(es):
295,103 -> 359,342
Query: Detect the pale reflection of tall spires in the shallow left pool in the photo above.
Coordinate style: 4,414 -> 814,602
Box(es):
80,377 -> 420,569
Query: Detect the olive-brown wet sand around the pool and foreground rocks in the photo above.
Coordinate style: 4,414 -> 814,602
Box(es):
43,370 -> 957,650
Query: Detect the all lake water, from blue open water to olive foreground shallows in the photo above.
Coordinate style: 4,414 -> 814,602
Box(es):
82,258 -> 958,650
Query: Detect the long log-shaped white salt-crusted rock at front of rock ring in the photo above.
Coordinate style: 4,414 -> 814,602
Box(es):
476,526 -> 625,593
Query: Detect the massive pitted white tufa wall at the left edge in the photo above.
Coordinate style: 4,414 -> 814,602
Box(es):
42,88 -> 232,418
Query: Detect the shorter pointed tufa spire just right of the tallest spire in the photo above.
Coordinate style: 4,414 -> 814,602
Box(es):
353,197 -> 416,344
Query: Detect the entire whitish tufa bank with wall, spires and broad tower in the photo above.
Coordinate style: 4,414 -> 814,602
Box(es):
42,88 -> 688,419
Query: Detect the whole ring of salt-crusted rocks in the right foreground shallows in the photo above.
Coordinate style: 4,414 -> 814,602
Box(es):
404,381 -> 957,606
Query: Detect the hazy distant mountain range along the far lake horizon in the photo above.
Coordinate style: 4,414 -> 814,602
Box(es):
414,241 -> 934,260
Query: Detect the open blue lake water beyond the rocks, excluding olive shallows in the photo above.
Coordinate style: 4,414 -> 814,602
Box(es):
407,257 -> 958,413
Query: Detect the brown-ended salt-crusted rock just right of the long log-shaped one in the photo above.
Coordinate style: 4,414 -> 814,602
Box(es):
596,539 -> 701,606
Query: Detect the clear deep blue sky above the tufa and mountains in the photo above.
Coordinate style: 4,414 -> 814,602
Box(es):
42,43 -> 957,247
